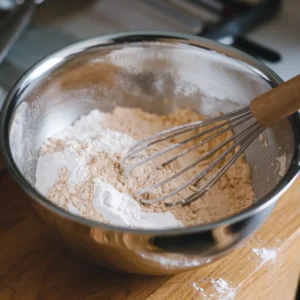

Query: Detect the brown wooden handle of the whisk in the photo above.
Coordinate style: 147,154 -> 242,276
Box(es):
250,75 -> 300,127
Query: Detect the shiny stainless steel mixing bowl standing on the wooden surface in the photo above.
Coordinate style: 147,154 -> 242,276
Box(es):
1,32 -> 300,274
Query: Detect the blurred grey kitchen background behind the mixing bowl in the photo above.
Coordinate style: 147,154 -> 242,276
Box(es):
0,0 -> 300,106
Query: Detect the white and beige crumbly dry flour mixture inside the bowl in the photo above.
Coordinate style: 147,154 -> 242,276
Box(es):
35,107 -> 254,229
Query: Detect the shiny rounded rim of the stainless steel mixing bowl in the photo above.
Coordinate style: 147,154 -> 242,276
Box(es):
0,31 -> 300,236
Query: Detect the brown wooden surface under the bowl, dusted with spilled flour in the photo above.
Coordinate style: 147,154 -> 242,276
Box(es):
0,157 -> 300,300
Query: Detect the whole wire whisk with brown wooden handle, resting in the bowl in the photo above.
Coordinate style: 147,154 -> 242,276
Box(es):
121,75 -> 300,206
